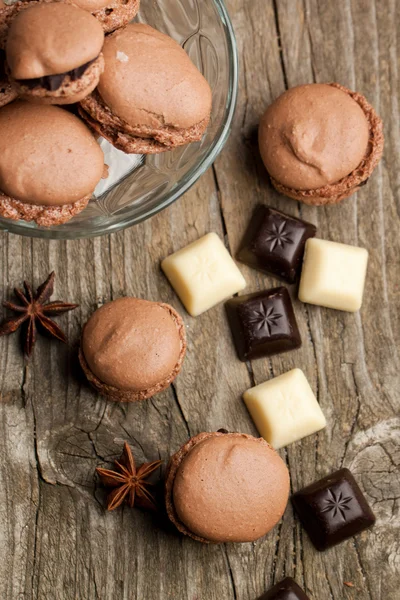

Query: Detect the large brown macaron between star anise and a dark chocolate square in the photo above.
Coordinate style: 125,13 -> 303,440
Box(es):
166,432 -> 289,543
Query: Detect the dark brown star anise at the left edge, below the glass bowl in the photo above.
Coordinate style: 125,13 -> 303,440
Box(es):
0,271 -> 78,356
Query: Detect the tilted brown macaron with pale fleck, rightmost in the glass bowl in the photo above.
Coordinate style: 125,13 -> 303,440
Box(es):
80,23 -> 212,154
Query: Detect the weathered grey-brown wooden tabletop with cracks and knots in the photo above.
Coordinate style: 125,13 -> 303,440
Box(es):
0,0 -> 400,600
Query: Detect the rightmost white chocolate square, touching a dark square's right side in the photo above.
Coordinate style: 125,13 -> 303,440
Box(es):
299,238 -> 368,312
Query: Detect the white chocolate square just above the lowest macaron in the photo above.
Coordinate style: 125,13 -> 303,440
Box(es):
243,369 -> 326,450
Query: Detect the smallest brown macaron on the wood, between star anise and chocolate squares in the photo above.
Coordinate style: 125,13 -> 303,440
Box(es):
79,298 -> 186,402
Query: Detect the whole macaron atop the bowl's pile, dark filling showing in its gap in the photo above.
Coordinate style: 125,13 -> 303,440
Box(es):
6,2 -> 104,104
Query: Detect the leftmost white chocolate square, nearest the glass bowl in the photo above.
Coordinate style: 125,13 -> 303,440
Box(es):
161,233 -> 246,317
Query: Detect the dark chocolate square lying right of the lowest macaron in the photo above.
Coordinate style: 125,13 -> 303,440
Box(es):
292,469 -> 375,550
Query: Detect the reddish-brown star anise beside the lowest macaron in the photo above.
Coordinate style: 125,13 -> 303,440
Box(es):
96,442 -> 162,510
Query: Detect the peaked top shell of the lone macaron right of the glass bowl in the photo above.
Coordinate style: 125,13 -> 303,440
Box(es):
259,83 -> 370,190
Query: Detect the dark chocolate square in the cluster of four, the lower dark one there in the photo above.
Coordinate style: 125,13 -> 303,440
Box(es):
226,287 -> 301,361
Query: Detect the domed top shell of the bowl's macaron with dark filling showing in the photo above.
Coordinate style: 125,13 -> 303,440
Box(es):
6,2 -> 104,80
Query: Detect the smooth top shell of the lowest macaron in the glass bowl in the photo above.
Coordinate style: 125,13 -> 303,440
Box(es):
0,100 -> 104,206
